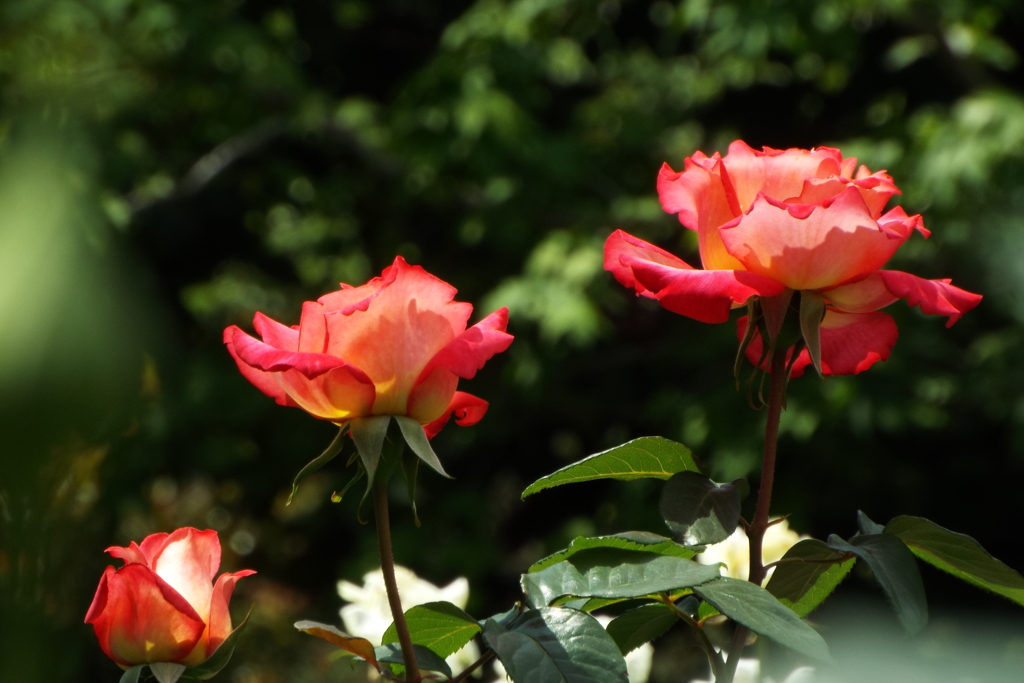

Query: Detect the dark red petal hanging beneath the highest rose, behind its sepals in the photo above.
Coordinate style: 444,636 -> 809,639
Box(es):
737,310 -> 899,377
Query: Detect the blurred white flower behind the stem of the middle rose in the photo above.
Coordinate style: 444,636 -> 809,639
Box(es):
338,564 -> 480,674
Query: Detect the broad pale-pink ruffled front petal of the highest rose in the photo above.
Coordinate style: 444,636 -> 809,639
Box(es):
721,186 -> 906,290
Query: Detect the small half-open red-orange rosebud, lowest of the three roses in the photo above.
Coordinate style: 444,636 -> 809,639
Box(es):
85,527 -> 256,668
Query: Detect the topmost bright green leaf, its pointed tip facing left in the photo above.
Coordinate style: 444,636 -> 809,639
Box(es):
522,436 -> 705,498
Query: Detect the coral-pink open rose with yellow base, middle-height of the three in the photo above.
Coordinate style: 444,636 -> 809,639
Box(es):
224,256 -> 512,436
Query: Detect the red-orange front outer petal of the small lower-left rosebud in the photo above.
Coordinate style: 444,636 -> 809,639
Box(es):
86,563 -> 206,667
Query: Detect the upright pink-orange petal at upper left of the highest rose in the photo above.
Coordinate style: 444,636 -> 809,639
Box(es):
657,158 -> 744,270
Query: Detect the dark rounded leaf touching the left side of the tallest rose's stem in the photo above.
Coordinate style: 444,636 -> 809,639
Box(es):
660,472 -> 741,546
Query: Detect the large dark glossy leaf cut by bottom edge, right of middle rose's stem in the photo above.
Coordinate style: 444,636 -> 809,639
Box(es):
483,607 -> 628,683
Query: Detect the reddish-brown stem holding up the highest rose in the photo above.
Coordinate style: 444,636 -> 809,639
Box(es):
721,345 -> 787,683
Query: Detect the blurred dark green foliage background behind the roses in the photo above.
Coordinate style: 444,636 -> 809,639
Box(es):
0,0 -> 1024,683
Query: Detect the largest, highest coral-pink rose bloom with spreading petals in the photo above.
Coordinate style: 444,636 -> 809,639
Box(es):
604,140 -> 981,376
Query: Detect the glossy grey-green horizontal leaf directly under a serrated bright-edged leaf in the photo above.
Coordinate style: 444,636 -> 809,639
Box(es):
521,548 -> 719,607
